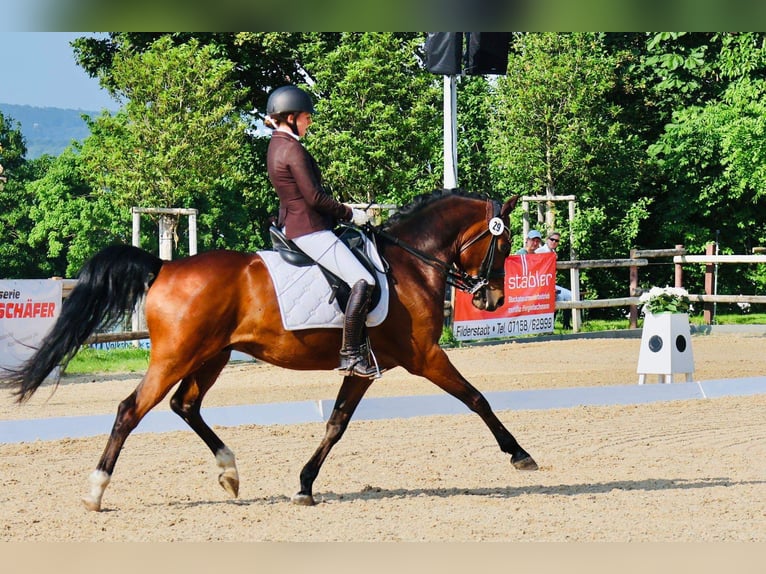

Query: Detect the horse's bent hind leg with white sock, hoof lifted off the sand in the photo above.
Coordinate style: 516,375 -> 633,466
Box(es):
170,351 -> 239,498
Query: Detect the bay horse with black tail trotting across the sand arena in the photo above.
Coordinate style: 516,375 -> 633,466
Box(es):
3,190 -> 537,511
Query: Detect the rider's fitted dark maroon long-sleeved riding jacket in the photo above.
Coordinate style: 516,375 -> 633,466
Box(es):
266,130 -> 352,239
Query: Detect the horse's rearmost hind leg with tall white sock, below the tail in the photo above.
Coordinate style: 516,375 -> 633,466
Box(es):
82,363 -> 183,511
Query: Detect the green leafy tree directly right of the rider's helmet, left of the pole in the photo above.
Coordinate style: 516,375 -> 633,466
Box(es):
303,33 -> 441,204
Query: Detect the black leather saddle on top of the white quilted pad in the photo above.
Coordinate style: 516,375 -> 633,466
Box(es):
269,223 -> 386,313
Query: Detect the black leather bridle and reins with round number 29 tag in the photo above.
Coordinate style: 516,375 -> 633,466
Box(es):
368,199 -> 510,295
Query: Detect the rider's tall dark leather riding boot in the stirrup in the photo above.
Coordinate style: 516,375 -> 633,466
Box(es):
338,280 -> 377,377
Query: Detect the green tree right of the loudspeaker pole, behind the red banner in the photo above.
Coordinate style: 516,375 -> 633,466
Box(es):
490,33 -> 649,297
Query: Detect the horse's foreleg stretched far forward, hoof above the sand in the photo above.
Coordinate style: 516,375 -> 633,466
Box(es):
422,349 -> 537,470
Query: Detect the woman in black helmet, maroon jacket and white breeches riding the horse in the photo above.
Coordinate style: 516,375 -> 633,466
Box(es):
265,86 -> 377,377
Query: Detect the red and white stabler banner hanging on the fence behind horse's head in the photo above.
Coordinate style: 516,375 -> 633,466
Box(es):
452,253 -> 556,340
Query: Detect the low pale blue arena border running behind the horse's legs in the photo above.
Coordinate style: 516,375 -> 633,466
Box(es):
0,377 -> 766,444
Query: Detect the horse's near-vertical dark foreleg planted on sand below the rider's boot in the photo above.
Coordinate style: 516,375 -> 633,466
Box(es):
292,377 -> 374,506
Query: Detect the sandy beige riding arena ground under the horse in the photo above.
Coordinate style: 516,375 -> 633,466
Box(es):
0,334 -> 766,542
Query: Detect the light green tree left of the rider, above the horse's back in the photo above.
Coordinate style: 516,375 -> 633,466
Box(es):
74,37 -> 247,253
